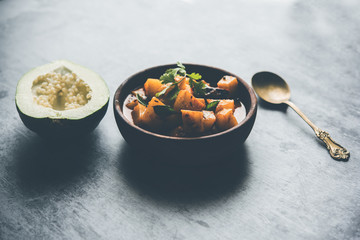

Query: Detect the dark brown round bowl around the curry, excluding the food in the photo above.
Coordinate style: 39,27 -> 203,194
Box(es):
114,64 -> 257,165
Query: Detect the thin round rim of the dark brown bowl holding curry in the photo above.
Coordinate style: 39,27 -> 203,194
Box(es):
113,63 -> 257,141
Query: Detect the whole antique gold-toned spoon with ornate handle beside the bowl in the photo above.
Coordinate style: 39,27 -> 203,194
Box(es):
252,72 -> 350,161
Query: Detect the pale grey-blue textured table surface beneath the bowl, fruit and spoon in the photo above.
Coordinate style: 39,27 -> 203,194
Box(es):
0,0 -> 360,239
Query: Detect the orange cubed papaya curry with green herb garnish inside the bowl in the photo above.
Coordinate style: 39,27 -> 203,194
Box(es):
123,62 -> 246,137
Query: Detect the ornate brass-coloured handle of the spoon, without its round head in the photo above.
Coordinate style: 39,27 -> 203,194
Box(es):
284,101 -> 350,161
